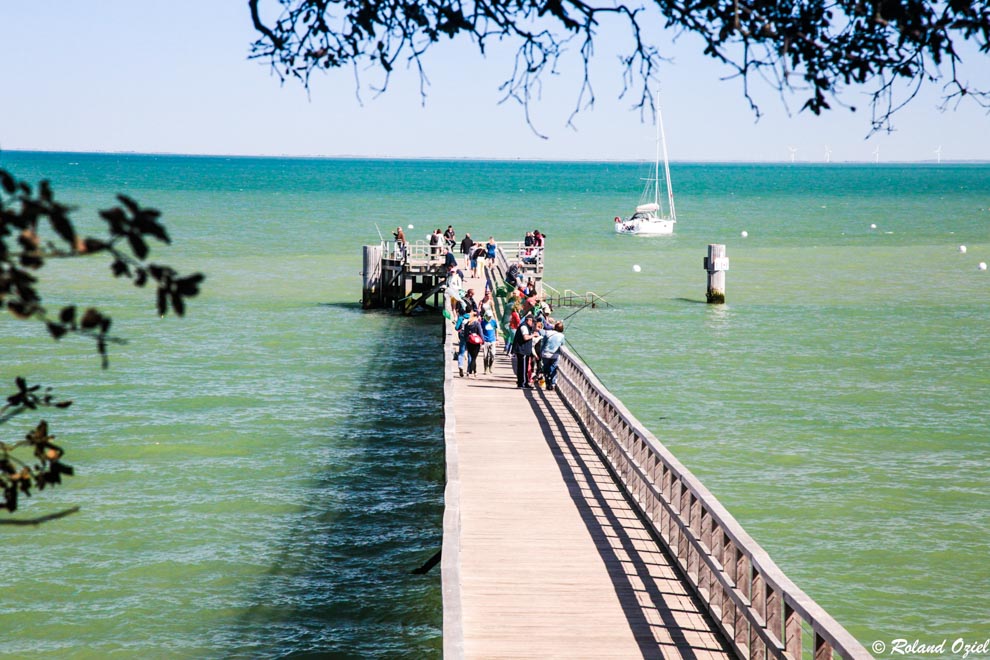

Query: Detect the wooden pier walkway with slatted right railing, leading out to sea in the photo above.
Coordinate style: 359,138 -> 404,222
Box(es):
362,245 -> 871,660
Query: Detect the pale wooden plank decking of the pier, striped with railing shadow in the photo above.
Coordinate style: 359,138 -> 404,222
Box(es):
445,280 -> 732,658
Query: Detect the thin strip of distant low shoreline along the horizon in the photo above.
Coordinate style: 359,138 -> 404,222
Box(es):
0,149 -> 990,167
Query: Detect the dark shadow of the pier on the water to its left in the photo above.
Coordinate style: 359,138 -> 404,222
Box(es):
225,314 -> 444,658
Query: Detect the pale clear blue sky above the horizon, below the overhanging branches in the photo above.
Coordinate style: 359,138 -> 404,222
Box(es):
0,0 -> 990,162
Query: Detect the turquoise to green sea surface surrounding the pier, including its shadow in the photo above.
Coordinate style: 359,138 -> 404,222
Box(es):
0,152 -> 990,658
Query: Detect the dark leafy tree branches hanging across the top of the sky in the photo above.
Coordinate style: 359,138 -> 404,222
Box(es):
248,0 -> 990,131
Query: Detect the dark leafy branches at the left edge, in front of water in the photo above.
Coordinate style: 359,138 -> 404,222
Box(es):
0,169 -> 204,524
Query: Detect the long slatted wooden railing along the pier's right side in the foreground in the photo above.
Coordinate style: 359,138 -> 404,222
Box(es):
557,348 -> 871,660
